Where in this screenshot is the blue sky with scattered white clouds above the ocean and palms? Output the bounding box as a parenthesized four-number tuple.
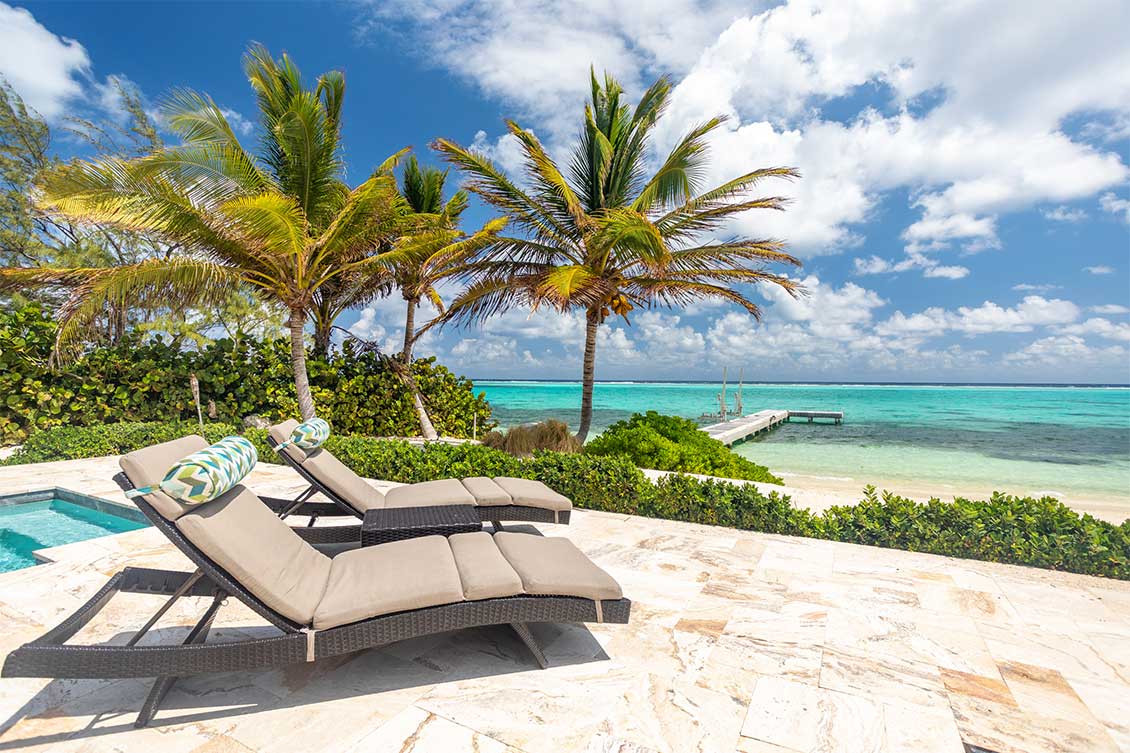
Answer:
(0, 0, 1130, 383)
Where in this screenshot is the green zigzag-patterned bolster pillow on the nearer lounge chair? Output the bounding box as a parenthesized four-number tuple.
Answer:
(128, 436, 259, 504)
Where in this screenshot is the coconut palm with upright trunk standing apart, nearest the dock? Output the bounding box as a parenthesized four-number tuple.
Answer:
(433, 73, 800, 441)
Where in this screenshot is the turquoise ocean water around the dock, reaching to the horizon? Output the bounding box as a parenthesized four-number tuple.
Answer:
(475, 381, 1130, 500)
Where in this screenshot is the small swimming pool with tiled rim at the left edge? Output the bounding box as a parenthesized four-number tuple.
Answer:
(0, 488, 149, 572)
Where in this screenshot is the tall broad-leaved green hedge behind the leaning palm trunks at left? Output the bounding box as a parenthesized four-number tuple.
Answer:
(0, 305, 494, 445)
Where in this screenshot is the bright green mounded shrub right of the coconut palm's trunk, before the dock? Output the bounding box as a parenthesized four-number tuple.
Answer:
(584, 410, 784, 484)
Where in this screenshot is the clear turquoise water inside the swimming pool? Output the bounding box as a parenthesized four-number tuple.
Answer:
(0, 499, 147, 572)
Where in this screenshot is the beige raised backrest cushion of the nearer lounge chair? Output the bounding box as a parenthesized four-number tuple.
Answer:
(121, 436, 330, 624)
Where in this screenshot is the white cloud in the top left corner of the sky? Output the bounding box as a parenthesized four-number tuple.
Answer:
(0, 2, 90, 121)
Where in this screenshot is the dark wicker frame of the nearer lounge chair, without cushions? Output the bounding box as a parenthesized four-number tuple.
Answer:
(0, 465, 632, 727)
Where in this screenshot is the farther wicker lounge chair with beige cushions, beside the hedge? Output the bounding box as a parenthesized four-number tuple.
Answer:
(267, 419, 573, 531)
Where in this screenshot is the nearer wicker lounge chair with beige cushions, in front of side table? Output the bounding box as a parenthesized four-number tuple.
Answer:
(2, 436, 632, 727)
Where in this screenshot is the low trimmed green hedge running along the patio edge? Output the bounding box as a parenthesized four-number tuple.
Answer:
(7, 423, 1130, 580)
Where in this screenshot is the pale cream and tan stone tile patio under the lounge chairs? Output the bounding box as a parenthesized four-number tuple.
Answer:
(0, 458, 1130, 753)
